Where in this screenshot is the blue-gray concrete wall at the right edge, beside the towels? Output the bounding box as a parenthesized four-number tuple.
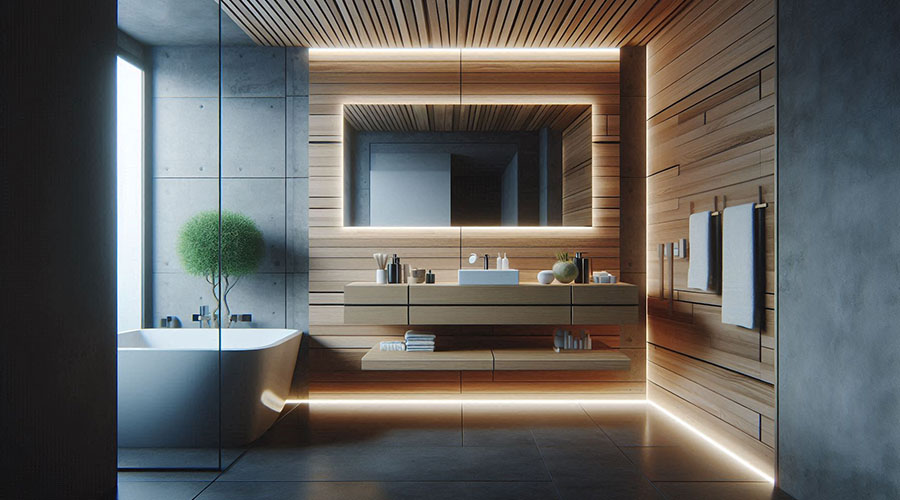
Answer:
(778, 0, 900, 499)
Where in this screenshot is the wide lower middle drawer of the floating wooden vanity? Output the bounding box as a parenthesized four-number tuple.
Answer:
(409, 305, 571, 325)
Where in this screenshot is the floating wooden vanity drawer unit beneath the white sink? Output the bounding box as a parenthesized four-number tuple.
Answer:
(344, 283, 639, 325)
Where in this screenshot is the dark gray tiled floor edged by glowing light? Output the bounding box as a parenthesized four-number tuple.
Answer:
(119, 402, 788, 500)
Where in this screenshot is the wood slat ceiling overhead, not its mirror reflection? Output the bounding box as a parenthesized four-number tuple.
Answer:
(221, 0, 690, 48)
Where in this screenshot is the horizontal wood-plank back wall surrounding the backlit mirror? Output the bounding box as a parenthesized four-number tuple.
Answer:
(309, 50, 632, 398)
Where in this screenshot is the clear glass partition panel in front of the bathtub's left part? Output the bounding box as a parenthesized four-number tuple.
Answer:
(117, 0, 227, 470)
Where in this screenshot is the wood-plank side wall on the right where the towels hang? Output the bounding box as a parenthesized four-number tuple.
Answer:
(647, 0, 775, 471)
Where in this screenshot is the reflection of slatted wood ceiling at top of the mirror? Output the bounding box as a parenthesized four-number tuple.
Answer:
(344, 104, 590, 132)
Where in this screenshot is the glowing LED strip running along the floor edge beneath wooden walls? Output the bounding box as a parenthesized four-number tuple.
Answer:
(285, 398, 775, 484)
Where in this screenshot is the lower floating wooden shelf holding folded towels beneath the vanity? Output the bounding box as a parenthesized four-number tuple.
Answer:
(362, 345, 631, 371)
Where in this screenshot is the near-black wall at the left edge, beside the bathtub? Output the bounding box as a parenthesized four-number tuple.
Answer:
(0, 0, 116, 499)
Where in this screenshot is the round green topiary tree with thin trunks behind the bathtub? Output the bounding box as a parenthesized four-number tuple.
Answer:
(178, 210, 264, 327)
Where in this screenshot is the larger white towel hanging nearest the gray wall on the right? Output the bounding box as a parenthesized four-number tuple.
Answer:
(722, 203, 758, 328)
